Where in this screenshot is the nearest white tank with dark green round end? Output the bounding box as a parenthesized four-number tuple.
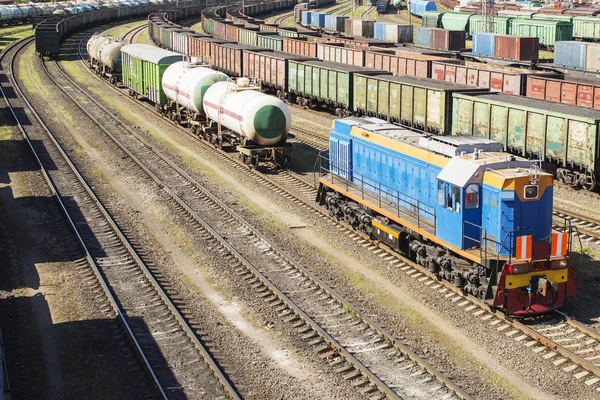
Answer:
(203, 78, 292, 146)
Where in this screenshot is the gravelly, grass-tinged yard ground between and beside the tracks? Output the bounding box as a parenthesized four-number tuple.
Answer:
(0, 9, 600, 400)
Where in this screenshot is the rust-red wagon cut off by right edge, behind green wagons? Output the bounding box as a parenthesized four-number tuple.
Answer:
(526, 76, 600, 110)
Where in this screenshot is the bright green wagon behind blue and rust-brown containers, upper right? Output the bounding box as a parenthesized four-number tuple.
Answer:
(510, 18, 573, 48)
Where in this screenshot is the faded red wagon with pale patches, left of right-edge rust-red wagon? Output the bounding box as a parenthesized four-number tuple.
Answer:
(431, 61, 561, 96)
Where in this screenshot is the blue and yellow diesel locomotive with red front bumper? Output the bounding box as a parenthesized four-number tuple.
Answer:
(317, 117, 576, 315)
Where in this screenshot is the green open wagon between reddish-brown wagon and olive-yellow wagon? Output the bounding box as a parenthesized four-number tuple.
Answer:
(288, 60, 382, 109)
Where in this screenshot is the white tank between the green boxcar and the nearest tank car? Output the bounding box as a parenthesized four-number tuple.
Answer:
(162, 61, 228, 114)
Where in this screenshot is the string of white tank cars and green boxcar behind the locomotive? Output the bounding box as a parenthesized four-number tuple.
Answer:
(87, 35, 293, 168)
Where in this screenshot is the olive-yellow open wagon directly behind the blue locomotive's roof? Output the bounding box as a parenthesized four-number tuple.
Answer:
(354, 74, 489, 135)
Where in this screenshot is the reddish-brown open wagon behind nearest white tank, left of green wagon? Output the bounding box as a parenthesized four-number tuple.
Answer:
(243, 51, 312, 94)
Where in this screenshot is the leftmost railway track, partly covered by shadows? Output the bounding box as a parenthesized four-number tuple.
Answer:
(7, 36, 239, 399)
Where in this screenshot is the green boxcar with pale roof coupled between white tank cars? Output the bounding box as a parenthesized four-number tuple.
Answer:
(121, 44, 183, 106)
